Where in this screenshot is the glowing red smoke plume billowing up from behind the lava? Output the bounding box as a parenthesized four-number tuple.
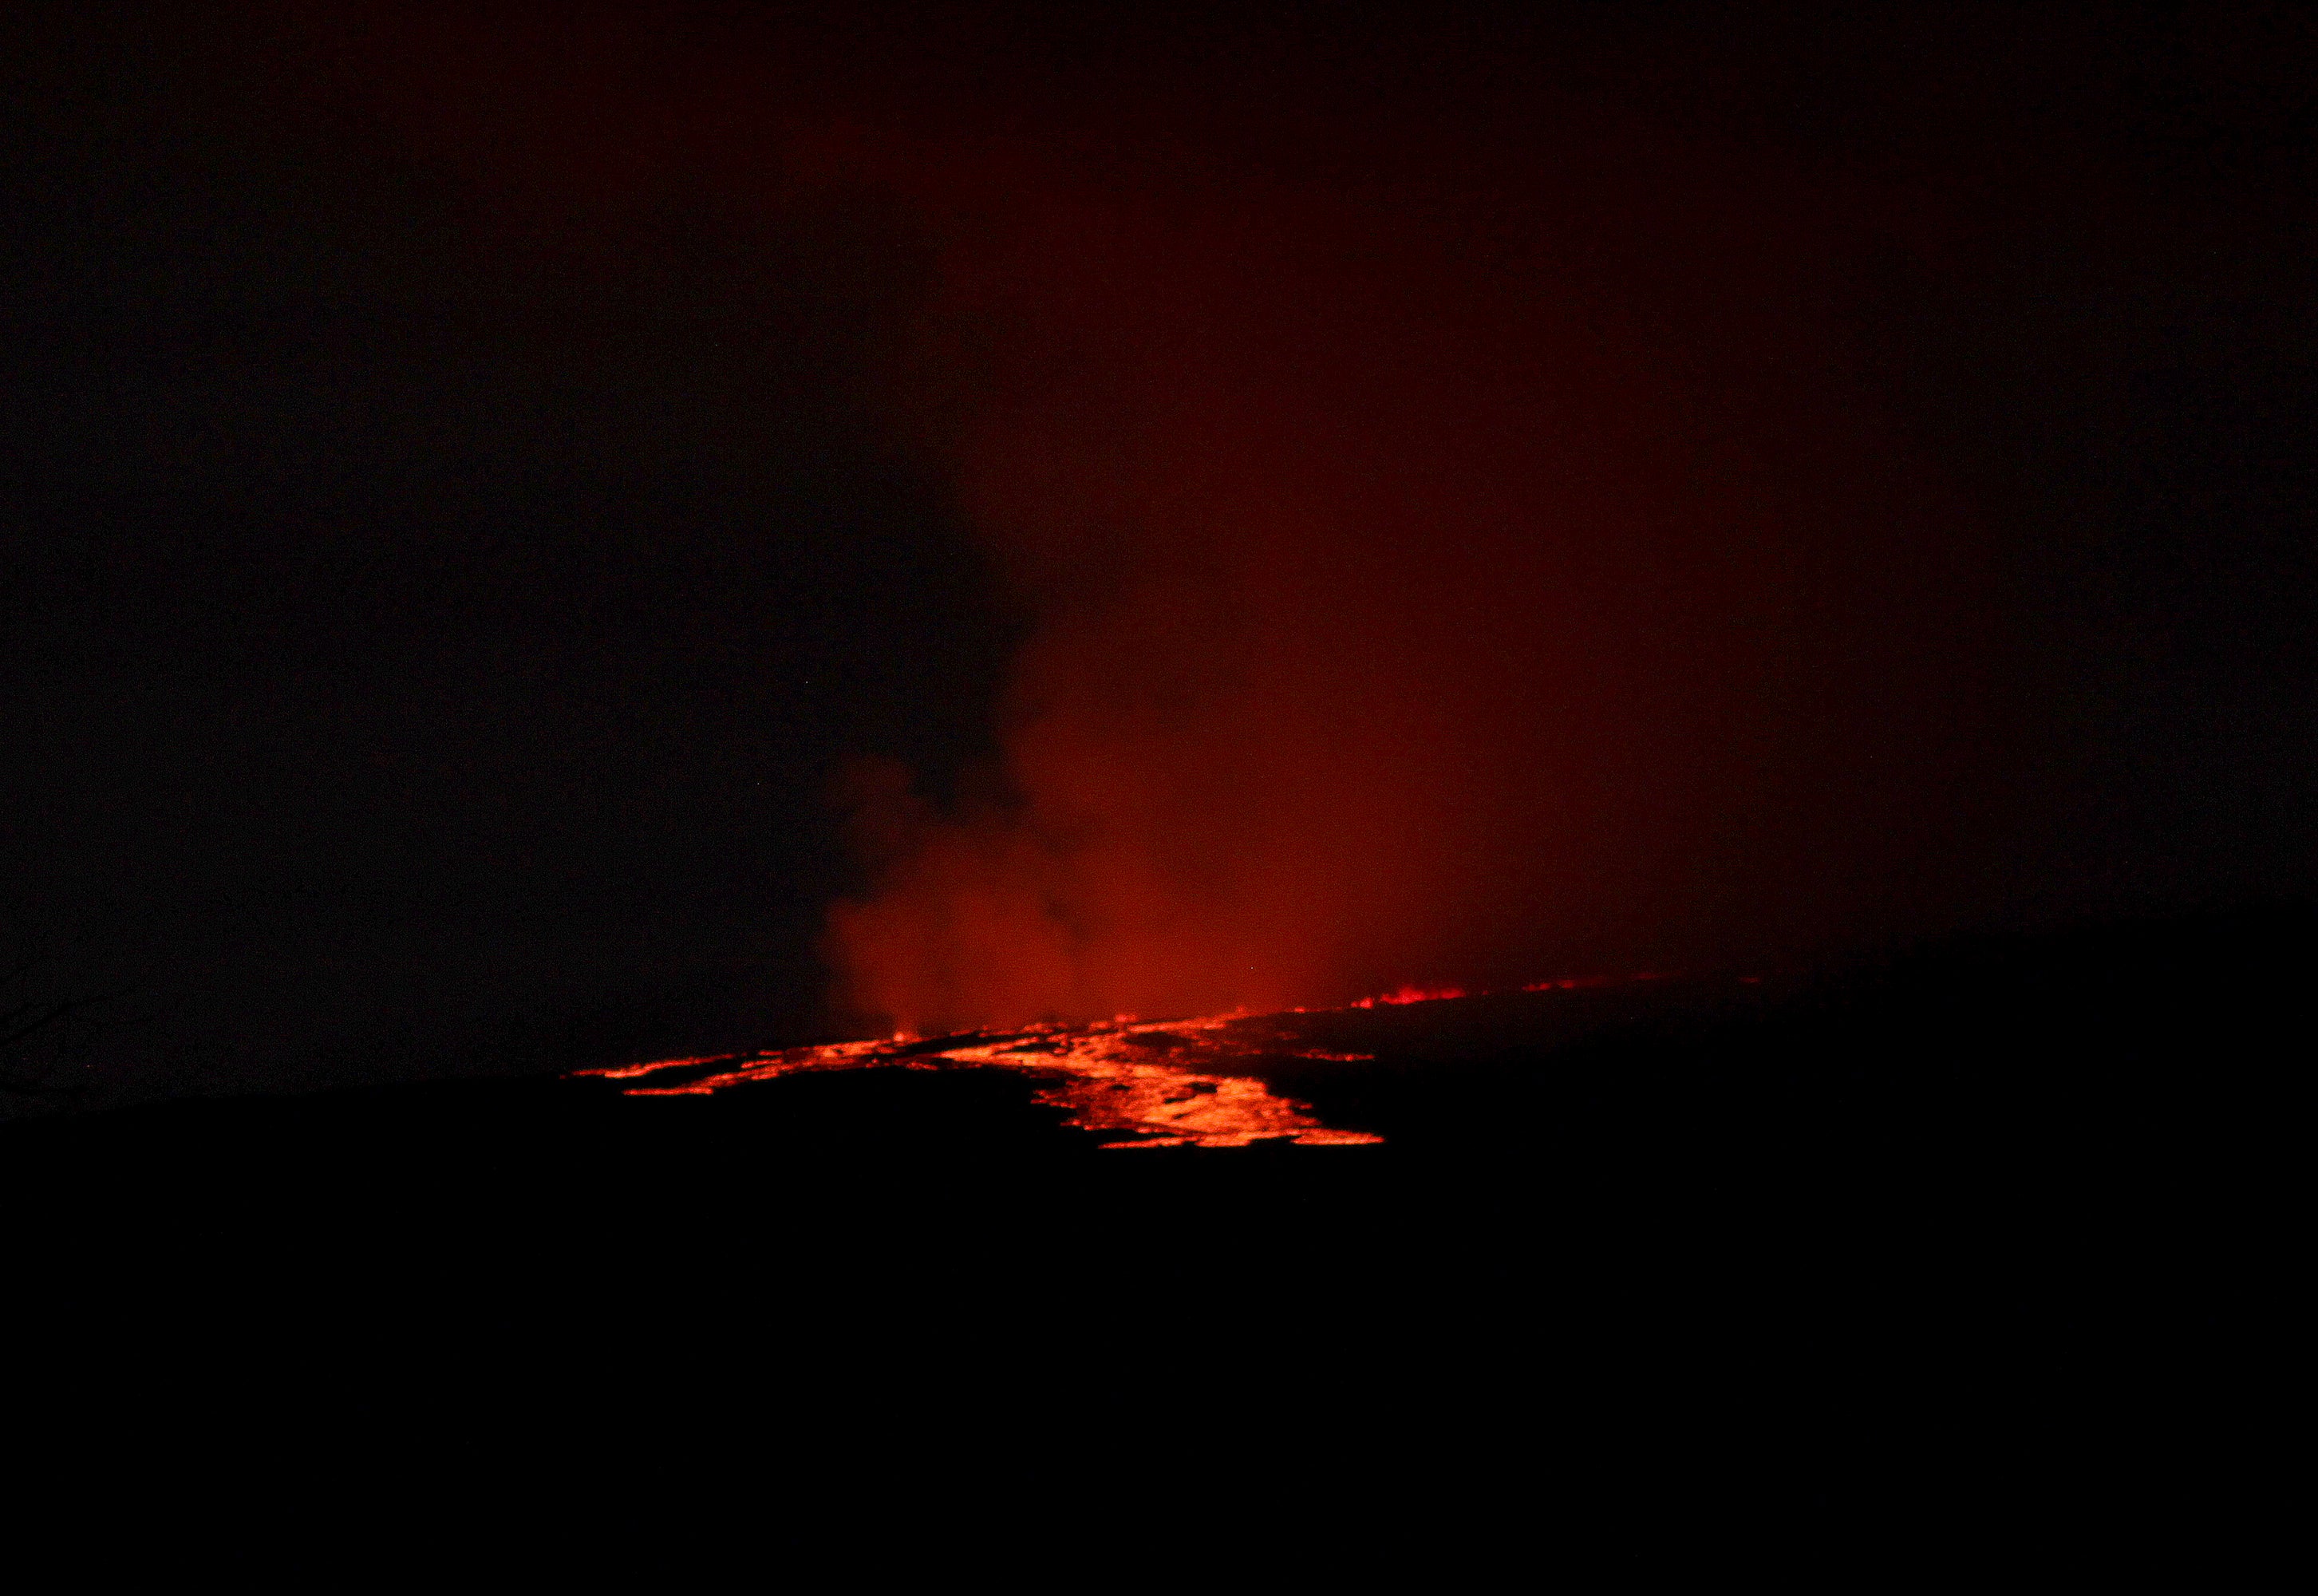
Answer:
(827, 109, 1970, 1033)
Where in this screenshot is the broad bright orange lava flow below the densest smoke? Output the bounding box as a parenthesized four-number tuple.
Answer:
(577, 1013, 1381, 1148)
